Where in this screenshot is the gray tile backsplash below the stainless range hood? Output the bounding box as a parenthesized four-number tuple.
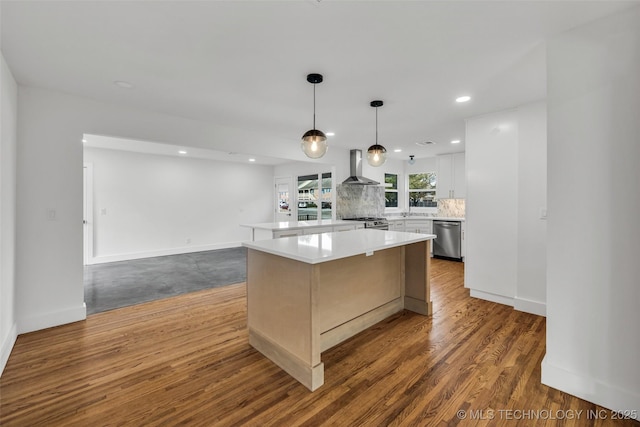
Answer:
(336, 184, 384, 219)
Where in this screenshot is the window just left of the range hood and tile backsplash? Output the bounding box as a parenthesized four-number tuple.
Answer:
(298, 172, 332, 221)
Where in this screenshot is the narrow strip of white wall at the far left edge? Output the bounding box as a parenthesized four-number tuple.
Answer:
(0, 52, 18, 374)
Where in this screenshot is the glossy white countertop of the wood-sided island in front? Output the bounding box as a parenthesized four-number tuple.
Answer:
(242, 231, 436, 264)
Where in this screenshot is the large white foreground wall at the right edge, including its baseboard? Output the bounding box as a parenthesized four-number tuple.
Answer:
(542, 8, 640, 413)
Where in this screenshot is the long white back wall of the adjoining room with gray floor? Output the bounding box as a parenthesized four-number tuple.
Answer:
(84, 148, 273, 263)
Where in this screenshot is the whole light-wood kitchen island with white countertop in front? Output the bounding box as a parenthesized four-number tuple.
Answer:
(243, 229, 435, 391)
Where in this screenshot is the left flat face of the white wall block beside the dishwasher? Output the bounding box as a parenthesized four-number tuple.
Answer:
(465, 110, 518, 305)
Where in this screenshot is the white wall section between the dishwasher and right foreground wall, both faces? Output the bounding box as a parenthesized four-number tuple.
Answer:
(465, 102, 547, 315)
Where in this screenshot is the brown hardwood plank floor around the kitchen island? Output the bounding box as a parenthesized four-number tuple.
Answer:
(0, 259, 640, 426)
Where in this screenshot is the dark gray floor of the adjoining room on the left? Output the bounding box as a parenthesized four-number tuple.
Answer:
(84, 247, 247, 315)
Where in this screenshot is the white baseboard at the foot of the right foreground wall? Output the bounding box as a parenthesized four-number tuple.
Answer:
(542, 355, 640, 419)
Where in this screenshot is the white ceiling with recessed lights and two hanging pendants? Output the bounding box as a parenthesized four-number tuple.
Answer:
(1, 0, 639, 159)
